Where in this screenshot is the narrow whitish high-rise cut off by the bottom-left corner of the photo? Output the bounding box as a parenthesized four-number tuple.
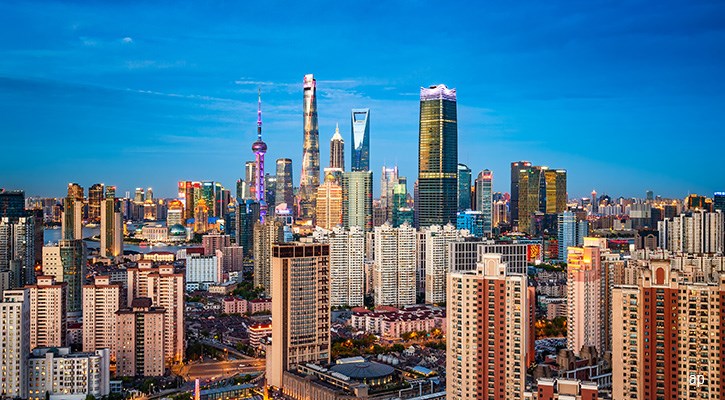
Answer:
(0, 289, 30, 399)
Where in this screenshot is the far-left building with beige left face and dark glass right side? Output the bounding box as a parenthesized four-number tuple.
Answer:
(43, 240, 88, 314)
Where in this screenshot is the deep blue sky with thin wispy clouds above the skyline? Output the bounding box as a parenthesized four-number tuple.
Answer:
(0, 1, 725, 197)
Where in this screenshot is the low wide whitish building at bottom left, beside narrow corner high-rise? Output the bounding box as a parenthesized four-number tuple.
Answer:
(28, 347, 111, 400)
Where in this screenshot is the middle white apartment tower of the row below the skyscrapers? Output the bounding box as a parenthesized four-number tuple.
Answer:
(373, 223, 416, 307)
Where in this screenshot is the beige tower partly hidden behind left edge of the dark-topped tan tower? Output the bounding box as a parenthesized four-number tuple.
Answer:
(254, 219, 284, 297)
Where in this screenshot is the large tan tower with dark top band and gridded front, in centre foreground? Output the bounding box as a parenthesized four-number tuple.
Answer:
(266, 243, 330, 387)
